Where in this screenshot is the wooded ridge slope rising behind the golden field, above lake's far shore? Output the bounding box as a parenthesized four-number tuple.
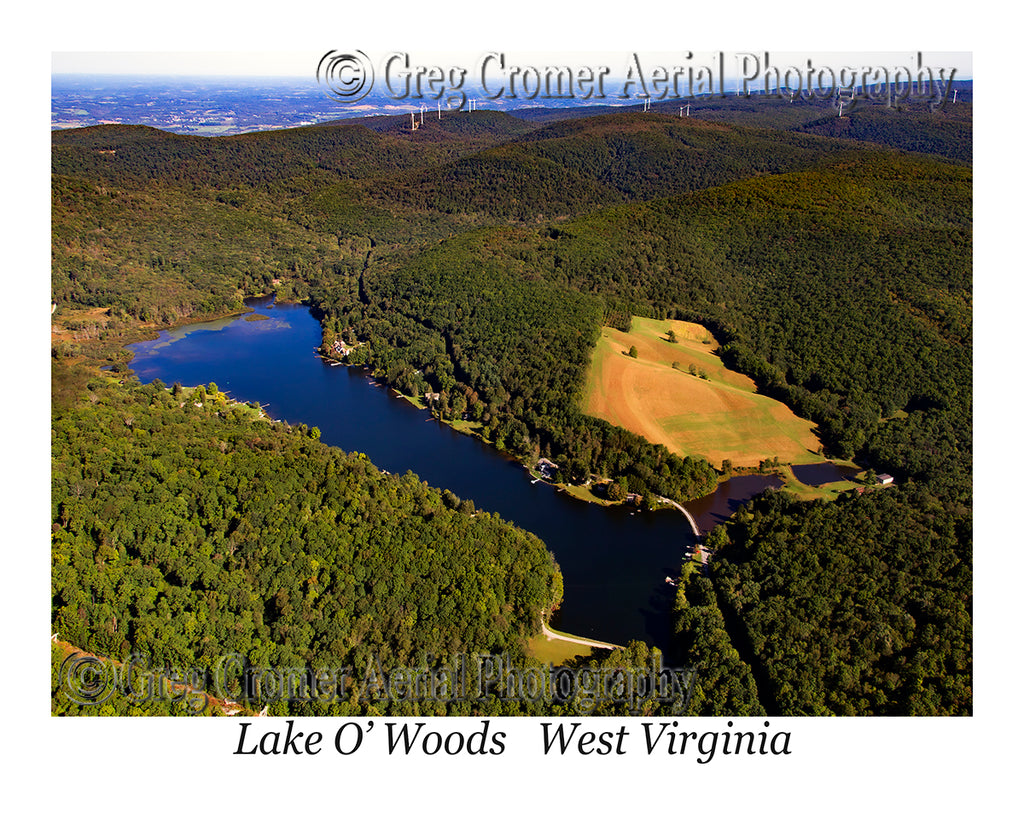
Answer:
(313, 148, 971, 507)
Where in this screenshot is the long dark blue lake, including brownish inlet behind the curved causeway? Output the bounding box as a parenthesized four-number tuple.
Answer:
(129, 299, 766, 647)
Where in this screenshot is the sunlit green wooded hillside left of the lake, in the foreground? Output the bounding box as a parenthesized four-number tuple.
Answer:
(51, 380, 561, 708)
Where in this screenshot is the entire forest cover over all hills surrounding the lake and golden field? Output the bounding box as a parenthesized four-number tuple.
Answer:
(52, 92, 973, 714)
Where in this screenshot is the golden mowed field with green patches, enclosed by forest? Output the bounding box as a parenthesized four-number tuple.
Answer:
(583, 317, 822, 467)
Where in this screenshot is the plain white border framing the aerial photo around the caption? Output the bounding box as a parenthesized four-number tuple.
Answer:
(12, 0, 1021, 816)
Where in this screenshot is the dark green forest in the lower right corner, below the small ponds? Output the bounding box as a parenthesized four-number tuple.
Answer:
(713, 489, 972, 715)
